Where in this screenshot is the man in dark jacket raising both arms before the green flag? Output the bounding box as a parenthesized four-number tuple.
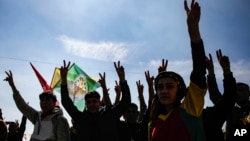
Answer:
(60, 60, 131, 141)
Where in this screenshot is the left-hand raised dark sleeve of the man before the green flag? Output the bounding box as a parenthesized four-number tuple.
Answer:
(61, 85, 81, 122)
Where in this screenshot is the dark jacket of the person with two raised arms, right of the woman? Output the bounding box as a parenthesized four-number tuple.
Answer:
(203, 73, 236, 141)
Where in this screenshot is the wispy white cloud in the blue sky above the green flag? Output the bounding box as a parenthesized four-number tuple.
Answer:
(58, 35, 131, 61)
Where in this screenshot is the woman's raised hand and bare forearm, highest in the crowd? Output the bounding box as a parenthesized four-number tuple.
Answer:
(184, 0, 201, 42)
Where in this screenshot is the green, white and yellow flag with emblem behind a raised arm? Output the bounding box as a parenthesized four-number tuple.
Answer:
(51, 63, 100, 111)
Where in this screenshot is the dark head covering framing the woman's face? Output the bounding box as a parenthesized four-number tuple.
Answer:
(154, 71, 187, 102)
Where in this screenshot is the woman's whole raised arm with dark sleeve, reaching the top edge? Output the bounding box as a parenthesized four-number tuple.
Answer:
(184, 0, 206, 88)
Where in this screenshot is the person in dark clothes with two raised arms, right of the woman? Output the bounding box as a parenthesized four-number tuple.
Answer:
(203, 50, 236, 141)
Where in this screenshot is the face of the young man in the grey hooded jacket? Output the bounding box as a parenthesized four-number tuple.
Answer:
(40, 97, 55, 113)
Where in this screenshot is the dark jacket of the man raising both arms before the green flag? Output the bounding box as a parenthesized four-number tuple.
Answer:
(61, 82, 131, 141)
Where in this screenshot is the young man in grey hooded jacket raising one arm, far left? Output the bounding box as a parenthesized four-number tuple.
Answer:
(4, 71, 70, 141)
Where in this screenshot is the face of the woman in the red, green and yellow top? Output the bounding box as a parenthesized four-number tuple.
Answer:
(157, 77, 178, 106)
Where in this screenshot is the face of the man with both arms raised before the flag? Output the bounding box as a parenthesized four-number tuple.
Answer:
(85, 98, 101, 113)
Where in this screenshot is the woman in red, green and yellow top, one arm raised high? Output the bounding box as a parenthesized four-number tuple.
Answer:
(149, 0, 207, 141)
